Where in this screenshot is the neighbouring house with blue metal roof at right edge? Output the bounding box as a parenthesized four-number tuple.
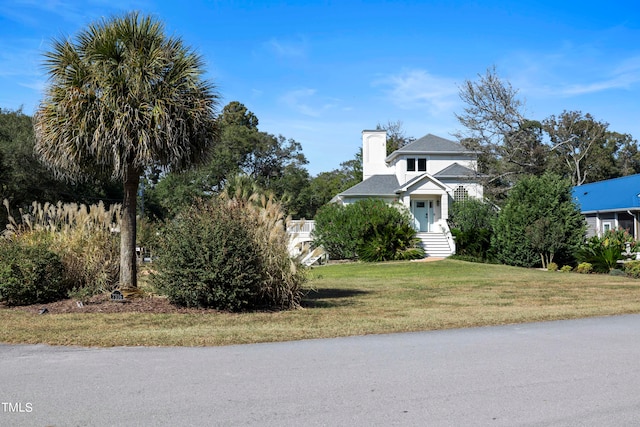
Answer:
(572, 174, 640, 239)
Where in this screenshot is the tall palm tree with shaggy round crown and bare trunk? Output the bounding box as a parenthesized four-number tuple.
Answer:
(34, 12, 219, 288)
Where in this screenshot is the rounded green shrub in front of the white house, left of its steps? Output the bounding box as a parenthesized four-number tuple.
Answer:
(313, 199, 424, 261)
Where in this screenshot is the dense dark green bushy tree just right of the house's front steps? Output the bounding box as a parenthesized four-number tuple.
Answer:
(491, 174, 586, 267)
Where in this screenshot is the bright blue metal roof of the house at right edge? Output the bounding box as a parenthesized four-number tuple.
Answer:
(573, 174, 640, 213)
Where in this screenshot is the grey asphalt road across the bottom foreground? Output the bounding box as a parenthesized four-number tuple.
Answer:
(0, 315, 640, 426)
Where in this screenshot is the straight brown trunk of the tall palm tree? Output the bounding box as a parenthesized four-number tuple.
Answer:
(120, 166, 140, 289)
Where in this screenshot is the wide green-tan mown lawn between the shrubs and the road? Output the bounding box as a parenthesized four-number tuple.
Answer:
(0, 260, 640, 346)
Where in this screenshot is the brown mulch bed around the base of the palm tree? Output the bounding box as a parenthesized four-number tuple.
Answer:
(0, 294, 217, 314)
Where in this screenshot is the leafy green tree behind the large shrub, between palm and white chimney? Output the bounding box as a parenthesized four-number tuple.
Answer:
(145, 101, 310, 218)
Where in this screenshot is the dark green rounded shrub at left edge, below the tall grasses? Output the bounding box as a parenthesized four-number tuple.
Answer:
(0, 240, 69, 305)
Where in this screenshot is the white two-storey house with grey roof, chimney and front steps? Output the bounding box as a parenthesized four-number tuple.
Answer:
(332, 130, 483, 257)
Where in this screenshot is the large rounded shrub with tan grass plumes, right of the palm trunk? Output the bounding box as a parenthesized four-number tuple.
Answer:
(151, 196, 304, 311)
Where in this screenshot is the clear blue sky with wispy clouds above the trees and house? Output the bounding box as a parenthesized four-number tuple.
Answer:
(0, 0, 640, 175)
